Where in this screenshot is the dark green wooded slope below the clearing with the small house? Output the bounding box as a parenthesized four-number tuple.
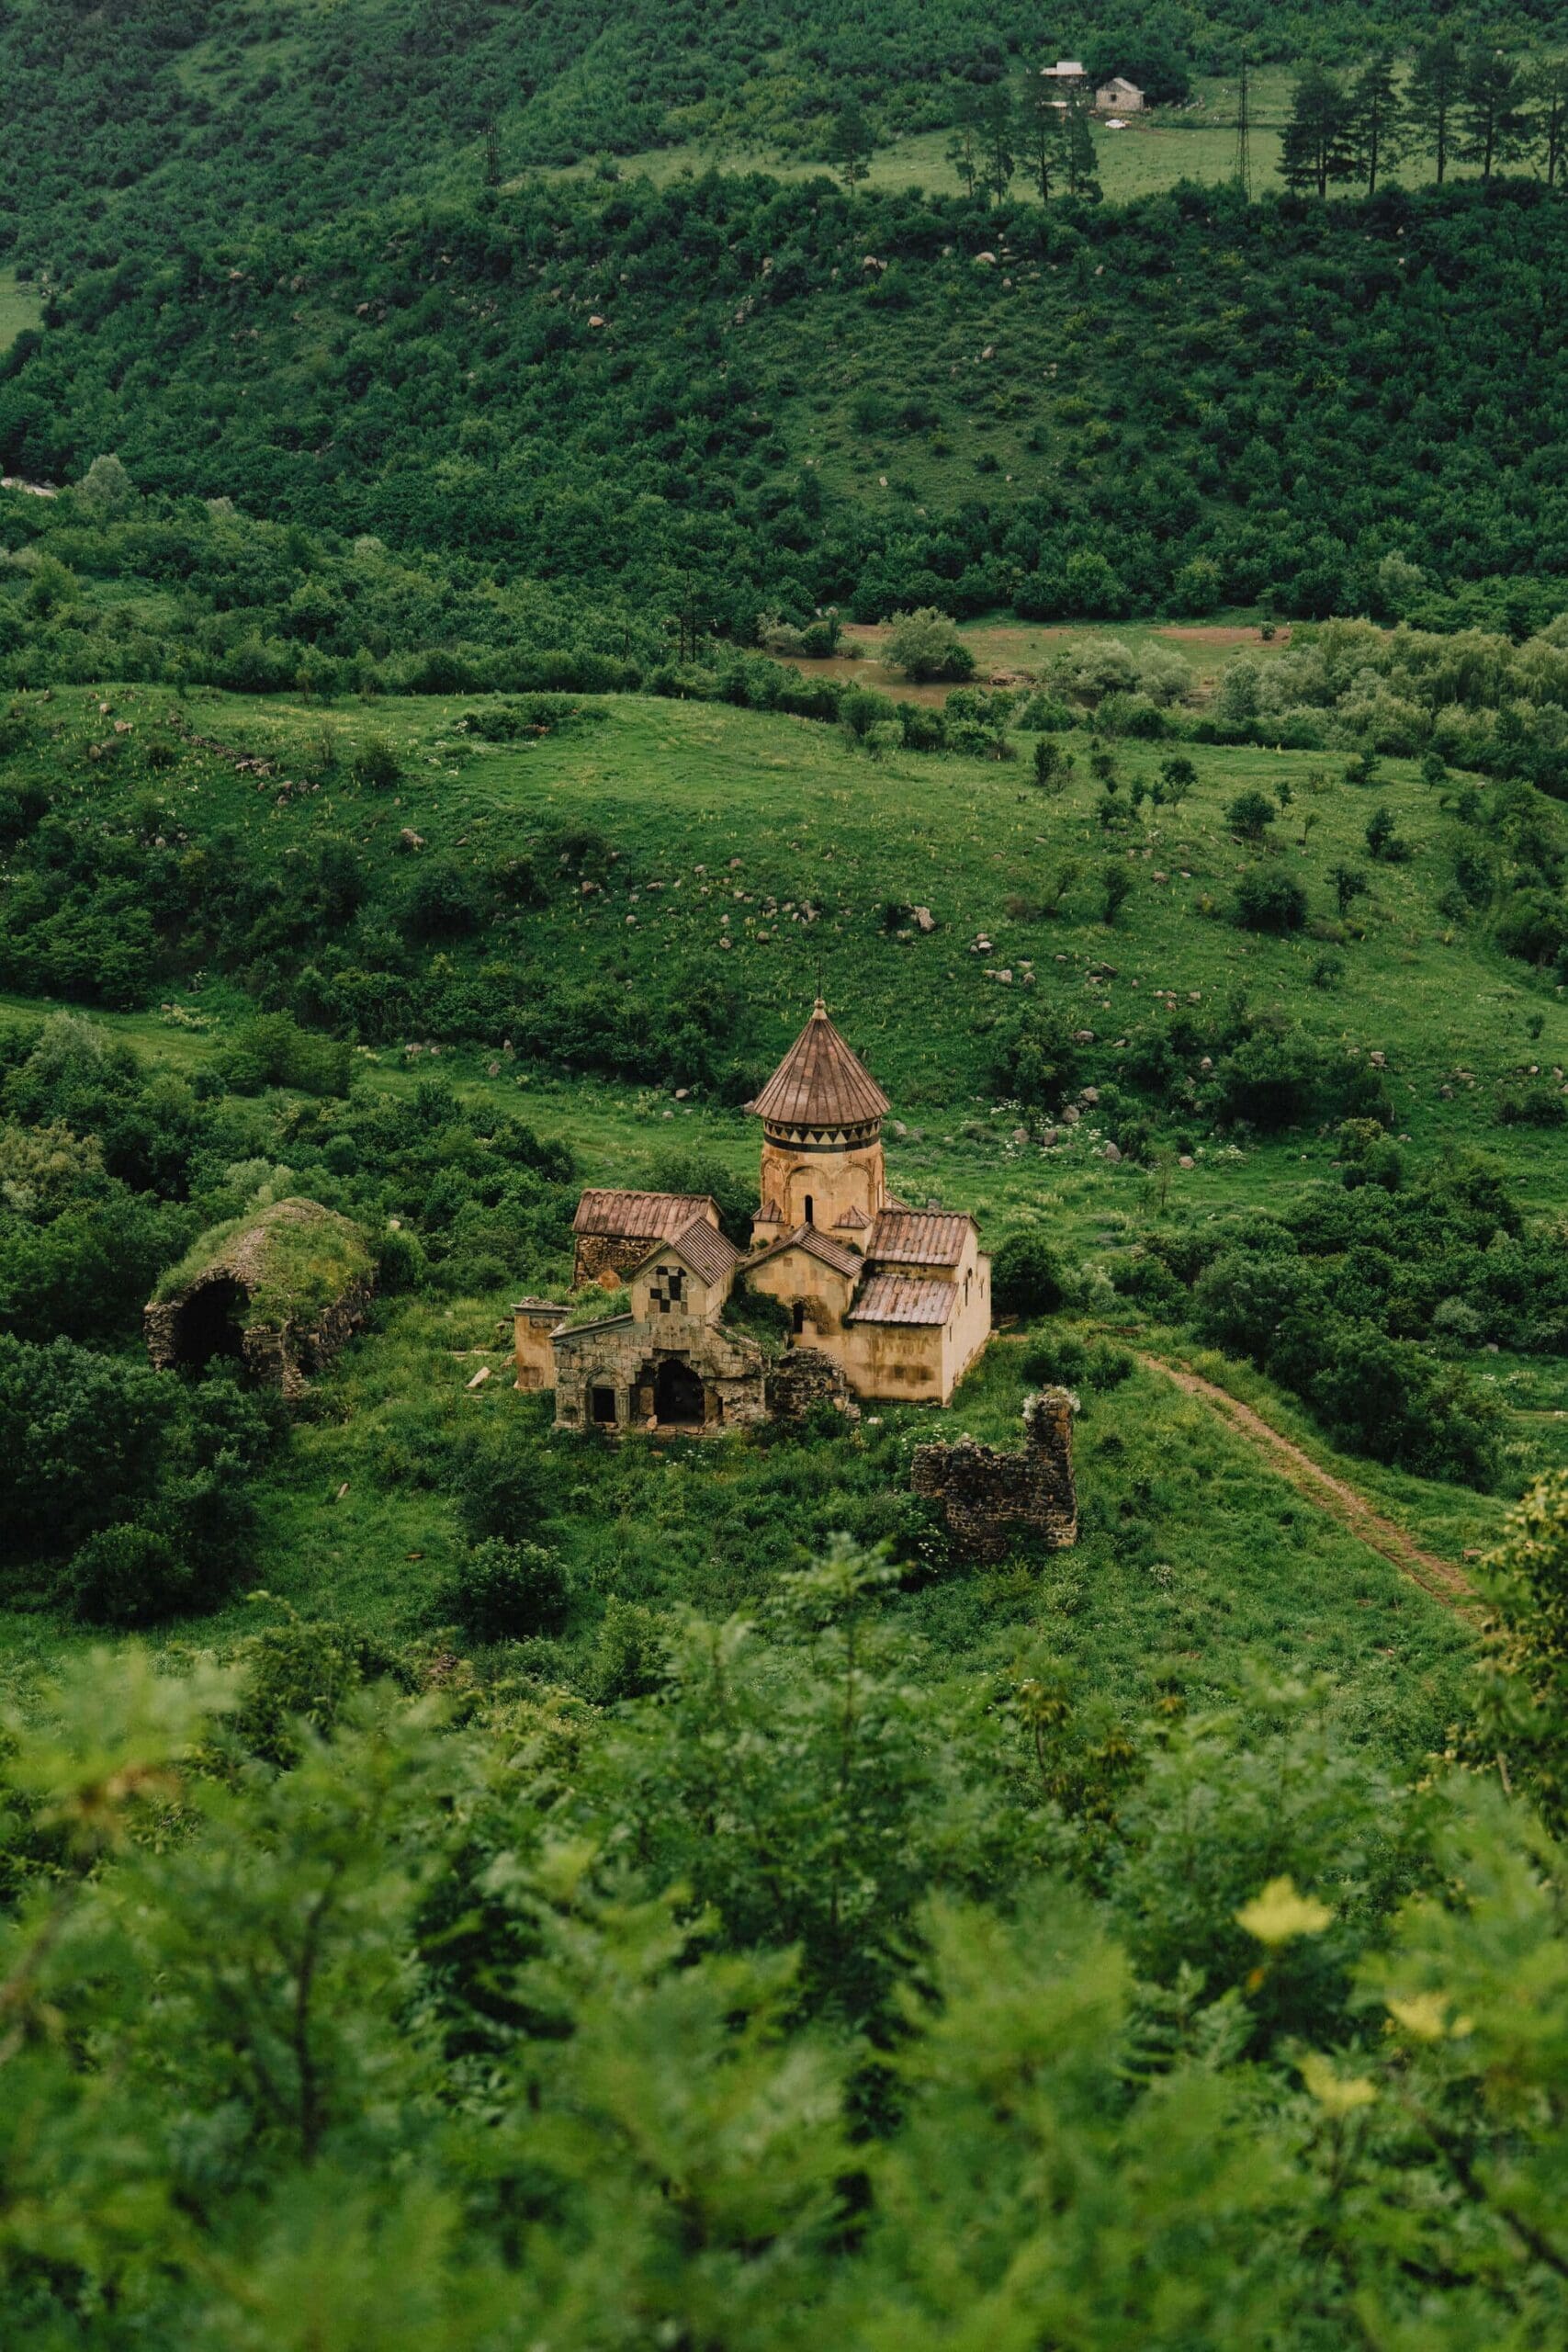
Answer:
(0, 174, 1568, 651)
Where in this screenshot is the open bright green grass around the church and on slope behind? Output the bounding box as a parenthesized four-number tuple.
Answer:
(3, 689, 1568, 1755)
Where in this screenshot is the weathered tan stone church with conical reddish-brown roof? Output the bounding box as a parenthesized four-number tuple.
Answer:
(514, 997, 989, 1430)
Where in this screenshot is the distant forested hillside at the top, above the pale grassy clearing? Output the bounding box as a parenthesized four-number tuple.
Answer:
(0, 0, 1563, 270)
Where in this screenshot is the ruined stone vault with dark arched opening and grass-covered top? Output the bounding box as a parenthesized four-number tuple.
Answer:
(143, 1200, 376, 1397)
